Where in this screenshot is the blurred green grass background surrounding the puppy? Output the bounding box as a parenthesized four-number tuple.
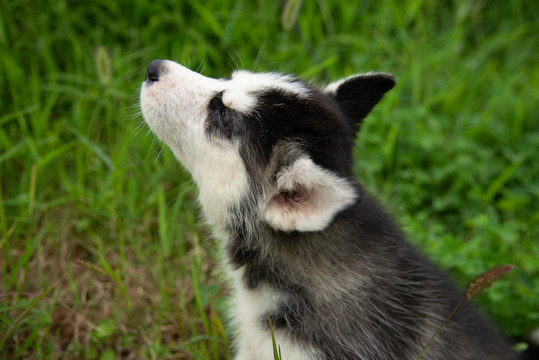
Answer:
(0, 0, 539, 360)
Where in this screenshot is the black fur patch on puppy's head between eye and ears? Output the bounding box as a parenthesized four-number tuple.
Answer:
(239, 90, 354, 177)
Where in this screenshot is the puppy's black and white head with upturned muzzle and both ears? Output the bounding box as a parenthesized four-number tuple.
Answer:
(140, 60, 395, 231)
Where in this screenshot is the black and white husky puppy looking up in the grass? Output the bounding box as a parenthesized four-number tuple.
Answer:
(140, 60, 515, 360)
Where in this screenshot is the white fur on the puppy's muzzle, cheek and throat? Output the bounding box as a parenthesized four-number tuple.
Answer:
(140, 61, 248, 225)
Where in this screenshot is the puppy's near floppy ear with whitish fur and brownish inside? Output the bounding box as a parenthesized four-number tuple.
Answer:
(262, 157, 358, 232)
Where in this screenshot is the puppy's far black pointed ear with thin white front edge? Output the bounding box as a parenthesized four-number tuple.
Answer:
(324, 73, 396, 131)
